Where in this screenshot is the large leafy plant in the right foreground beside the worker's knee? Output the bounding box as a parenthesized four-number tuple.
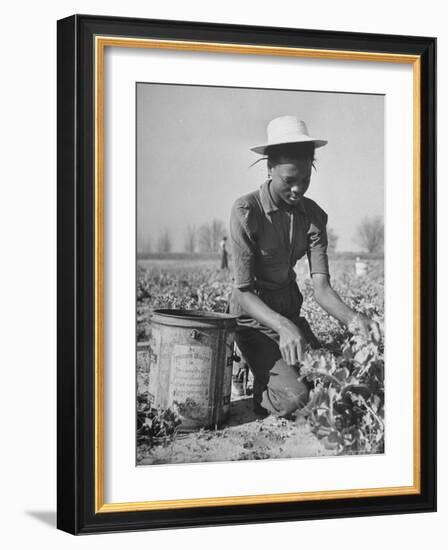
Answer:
(300, 335, 384, 454)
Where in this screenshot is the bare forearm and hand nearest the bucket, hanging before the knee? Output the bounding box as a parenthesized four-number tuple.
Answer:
(234, 289, 305, 365)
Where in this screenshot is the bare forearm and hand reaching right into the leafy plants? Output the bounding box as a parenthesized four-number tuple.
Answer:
(312, 273, 381, 341)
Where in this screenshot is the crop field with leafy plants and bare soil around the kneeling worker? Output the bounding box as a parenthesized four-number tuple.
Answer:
(137, 259, 385, 464)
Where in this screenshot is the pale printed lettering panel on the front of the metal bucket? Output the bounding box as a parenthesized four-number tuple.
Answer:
(168, 344, 212, 418)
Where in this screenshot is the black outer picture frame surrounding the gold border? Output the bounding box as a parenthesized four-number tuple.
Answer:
(57, 15, 436, 534)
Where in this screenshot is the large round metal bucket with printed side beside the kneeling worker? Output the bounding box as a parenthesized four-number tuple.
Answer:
(148, 309, 236, 430)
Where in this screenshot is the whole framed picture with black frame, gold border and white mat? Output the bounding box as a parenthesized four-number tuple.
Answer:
(58, 15, 436, 534)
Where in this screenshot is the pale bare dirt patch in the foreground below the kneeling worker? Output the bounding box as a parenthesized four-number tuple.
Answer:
(137, 396, 335, 465)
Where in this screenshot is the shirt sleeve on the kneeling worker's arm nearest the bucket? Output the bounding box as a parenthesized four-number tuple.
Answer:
(230, 199, 256, 289)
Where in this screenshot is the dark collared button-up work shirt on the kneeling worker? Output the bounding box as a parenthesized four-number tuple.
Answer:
(230, 180, 329, 290)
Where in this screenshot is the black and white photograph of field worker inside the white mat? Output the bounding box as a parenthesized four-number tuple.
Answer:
(136, 82, 387, 466)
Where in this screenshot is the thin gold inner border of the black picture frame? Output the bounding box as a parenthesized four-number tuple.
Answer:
(94, 36, 421, 513)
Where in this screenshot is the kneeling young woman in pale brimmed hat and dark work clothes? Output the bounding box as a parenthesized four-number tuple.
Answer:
(229, 116, 380, 416)
